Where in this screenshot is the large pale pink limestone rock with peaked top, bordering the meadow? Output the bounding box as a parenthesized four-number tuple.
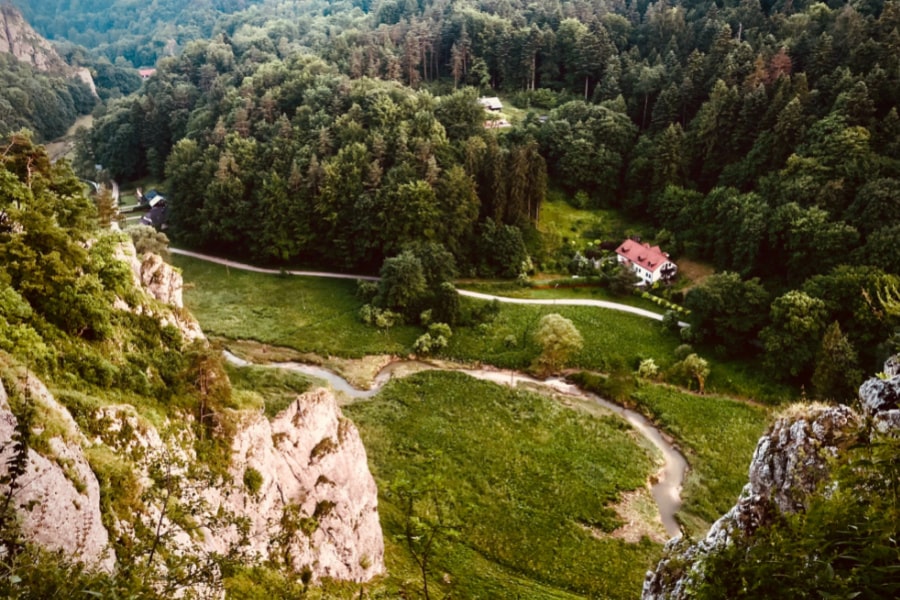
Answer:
(210, 389, 384, 581)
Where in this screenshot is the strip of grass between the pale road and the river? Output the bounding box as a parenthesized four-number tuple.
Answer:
(178, 256, 791, 403)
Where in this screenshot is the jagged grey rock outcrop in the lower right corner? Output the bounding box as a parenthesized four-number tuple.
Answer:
(642, 357, 900, 600)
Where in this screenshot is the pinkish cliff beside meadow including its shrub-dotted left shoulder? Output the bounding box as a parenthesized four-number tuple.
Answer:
(94, 389, 384, 586)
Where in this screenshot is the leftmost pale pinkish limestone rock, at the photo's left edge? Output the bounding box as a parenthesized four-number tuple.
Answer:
(0, 373, 115, 571)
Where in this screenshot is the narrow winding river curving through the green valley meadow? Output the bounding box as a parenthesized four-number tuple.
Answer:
(225, 351, 688, 537)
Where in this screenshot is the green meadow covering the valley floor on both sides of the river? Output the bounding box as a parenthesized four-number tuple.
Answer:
(181, 251, 778, 598)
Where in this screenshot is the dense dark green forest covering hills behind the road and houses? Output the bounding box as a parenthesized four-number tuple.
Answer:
(17, 0, 900, 394)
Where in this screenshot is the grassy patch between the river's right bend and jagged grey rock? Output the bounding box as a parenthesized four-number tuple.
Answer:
(632, 385, 769, 533)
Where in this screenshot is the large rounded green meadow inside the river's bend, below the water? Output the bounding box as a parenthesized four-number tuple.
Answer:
(344, 372, 660, 598)
